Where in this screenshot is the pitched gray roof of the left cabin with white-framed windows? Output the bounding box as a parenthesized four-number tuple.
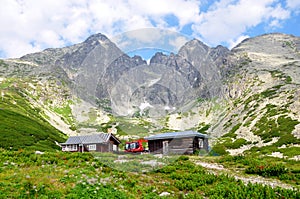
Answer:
(62, 133, 115, 145)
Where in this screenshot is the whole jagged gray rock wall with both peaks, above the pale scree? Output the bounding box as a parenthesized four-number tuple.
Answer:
(1, 33, 233, 115)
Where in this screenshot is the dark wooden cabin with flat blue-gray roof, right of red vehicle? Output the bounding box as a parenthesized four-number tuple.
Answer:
(145, 131, 208, 154)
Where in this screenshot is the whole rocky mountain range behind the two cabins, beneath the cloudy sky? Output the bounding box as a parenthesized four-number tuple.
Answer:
(0, 33, 300, 158)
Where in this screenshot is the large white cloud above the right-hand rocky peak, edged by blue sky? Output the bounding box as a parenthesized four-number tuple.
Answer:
(192, 0, 290, 45)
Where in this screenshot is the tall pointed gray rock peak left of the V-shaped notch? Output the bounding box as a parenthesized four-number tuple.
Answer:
(55, 34, 123, 102)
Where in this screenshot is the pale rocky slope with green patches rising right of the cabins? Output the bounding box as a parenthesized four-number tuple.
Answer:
(207, 34, 300, 158)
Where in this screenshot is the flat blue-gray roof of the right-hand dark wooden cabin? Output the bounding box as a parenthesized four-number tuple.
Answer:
(145, 131, 208, 140)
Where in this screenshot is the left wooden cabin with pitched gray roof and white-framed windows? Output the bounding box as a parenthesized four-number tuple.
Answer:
(60, 133, 121, 152)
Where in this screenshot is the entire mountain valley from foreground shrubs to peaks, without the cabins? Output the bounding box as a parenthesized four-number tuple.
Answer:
(0, 33, 300, 198)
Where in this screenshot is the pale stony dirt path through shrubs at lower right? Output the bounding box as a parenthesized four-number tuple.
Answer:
(194, 160, 295, 189)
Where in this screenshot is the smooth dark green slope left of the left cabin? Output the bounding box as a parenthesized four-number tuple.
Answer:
(0, 79, 65, 151)
